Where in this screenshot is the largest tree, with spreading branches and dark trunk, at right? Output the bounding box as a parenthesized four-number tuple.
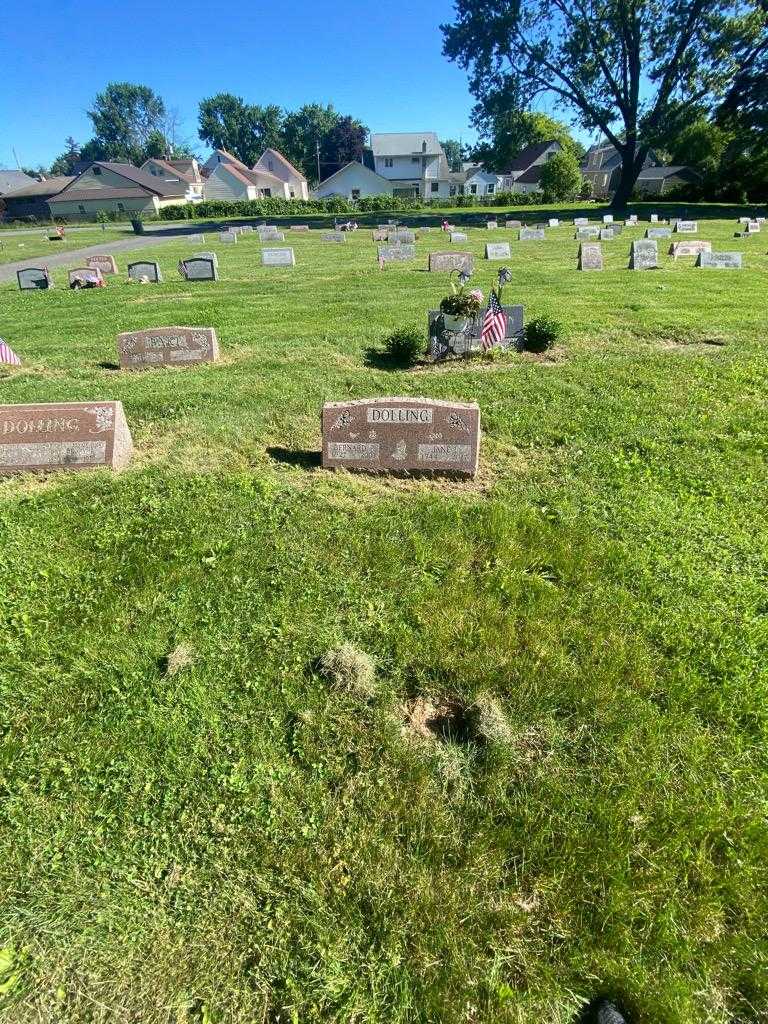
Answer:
(441, 0, 768, 208)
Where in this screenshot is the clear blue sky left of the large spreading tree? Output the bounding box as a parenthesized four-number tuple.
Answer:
(0, 0, 524, 167)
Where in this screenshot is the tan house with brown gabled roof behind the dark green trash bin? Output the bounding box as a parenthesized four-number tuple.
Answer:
(47, 160, 186, 220)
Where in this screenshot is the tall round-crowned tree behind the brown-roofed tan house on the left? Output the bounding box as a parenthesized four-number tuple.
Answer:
(88, 82, 166, 164)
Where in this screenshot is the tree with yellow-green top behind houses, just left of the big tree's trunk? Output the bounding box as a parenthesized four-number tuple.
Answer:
(472, 105, 584, 173)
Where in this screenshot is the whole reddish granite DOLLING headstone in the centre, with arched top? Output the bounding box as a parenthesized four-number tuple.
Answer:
(323, 396, 480, 476)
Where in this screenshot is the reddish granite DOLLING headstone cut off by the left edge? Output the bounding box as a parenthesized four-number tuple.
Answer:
(0, 401, 133, 473)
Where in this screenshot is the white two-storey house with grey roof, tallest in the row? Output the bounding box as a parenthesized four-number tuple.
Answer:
(371, 131, 451, 199)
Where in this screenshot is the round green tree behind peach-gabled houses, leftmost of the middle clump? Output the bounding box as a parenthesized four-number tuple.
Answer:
(198, 92, 284, 167)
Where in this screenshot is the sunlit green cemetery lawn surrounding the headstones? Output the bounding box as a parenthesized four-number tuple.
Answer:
(0, 212, 768, 1024)
